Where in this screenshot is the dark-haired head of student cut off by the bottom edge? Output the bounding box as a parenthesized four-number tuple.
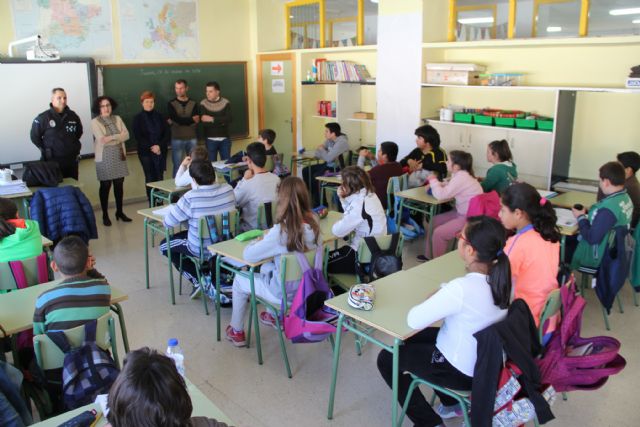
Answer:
(107, 347, 227, 427)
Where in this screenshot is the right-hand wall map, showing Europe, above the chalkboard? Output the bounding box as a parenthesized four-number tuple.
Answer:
(119, 0, 199, 60)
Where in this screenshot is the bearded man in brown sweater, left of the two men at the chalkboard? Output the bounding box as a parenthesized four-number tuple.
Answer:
(168, 79, 200, 178)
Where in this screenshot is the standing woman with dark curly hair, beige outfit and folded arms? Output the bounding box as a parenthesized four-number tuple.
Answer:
(91, 96, 131, 227)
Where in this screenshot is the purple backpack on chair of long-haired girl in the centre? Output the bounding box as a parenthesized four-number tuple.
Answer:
(281, 246, 336, 344)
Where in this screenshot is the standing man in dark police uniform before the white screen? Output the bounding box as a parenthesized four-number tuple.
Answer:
(31, 87, 82, 180)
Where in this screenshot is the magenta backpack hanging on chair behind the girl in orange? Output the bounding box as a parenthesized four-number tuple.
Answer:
(536, 279, 627, 392)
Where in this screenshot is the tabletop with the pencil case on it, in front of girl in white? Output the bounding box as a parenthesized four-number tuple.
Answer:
(325, 251, 465, 341)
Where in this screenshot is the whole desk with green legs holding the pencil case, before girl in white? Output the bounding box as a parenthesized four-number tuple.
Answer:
(325, 253, 465, 426)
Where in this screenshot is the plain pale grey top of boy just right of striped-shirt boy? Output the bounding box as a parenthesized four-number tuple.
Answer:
(233, 172, 280, 231)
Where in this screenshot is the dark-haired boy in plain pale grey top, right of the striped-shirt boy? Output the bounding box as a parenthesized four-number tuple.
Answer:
(233, 142, 280, 231)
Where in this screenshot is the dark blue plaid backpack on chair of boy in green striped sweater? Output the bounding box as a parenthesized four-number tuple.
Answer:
(47, 320, 120, 410)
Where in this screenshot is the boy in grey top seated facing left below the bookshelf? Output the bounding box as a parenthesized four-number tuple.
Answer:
(302, 122, 349, 205)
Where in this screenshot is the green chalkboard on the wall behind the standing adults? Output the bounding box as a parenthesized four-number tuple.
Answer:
(101, 62, 249, 150)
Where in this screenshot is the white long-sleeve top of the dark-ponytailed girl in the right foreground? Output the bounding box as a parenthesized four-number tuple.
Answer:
(407, 273, 507, 377)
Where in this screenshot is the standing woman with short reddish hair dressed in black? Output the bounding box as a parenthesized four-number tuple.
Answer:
(133, 90, 171, 204)
